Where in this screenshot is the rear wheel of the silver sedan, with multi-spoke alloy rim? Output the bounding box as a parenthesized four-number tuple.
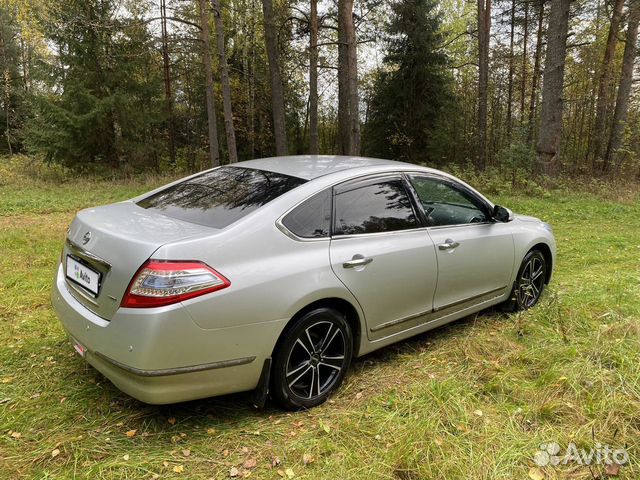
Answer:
(271, 308, 353, 410)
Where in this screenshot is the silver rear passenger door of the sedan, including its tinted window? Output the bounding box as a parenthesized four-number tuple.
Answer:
(330, 174, 437, 339)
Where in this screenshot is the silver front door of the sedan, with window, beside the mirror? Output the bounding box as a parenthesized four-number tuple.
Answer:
(409, 174, 514, 311)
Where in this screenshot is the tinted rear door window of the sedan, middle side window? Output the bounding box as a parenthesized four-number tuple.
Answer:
(334, 178, 418, 235)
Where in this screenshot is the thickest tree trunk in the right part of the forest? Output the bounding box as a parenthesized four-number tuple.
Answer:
(535, 0, 570, 176)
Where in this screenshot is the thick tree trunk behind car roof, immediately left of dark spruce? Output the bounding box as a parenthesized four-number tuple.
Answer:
(338, 0, 360, 155)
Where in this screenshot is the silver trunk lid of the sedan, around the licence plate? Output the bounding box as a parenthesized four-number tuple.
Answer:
(62, 201, 217, 320)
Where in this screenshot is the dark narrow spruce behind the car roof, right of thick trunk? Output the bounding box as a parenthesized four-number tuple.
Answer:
(364, 0, 450, 162)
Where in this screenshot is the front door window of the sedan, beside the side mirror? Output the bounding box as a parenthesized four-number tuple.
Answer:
(410, 175, 488, 227)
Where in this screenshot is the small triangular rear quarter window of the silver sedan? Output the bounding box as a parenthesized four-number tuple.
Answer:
(282, 189, 331, 238)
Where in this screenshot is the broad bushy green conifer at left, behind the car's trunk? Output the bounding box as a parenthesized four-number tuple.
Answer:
(26, 0, 163, 169)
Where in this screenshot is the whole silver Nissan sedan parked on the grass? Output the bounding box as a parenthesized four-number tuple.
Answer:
(52, 156, 556, 409)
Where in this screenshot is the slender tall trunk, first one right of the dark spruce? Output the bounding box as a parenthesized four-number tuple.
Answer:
(476, 0, 491, 171)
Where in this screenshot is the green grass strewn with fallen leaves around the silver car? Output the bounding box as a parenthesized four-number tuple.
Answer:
(0, 157, 640, 480)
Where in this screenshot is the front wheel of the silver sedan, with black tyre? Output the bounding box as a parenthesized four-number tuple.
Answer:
(506, 250, 547, 312)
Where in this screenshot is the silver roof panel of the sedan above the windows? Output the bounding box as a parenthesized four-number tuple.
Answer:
(233, 155, 416, 180)
